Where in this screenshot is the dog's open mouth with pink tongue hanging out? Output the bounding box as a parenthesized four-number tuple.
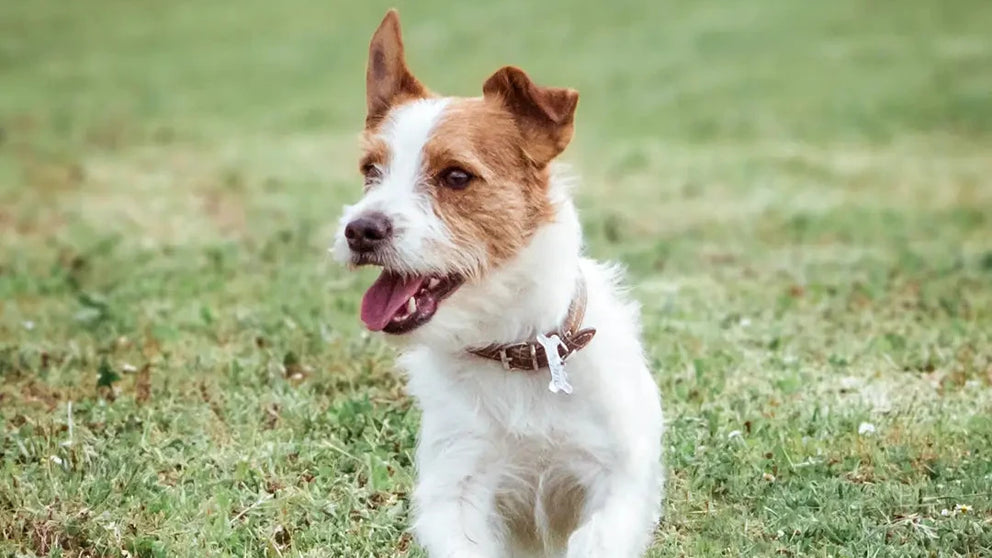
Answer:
(362, 270, 463, 334)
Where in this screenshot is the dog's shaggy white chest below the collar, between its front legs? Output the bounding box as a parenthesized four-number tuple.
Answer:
(402, 351, 628, 556)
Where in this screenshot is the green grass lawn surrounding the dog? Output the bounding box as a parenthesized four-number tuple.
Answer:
(0, 0, 992, 557)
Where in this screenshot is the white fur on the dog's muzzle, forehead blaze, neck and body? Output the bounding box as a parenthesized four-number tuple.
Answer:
(337, 101, 663, 558)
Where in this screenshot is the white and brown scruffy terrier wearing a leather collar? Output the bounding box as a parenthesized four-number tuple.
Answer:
(331, 10, 663, 558)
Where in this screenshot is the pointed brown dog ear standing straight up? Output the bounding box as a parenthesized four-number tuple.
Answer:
(365, 9, 428, 128)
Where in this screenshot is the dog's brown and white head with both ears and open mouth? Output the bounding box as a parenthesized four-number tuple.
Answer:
(334, 11, 578, 334)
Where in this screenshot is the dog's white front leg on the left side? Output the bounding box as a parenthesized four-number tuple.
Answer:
(413, 446, 500, 558)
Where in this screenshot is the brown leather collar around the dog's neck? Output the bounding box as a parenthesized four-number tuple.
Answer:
(468, 272, 596, 372)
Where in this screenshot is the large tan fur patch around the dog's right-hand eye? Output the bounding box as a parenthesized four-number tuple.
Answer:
(424, 98, 554, 272)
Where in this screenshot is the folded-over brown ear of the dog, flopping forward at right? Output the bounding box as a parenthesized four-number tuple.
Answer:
(482, 66, 579, 166)
